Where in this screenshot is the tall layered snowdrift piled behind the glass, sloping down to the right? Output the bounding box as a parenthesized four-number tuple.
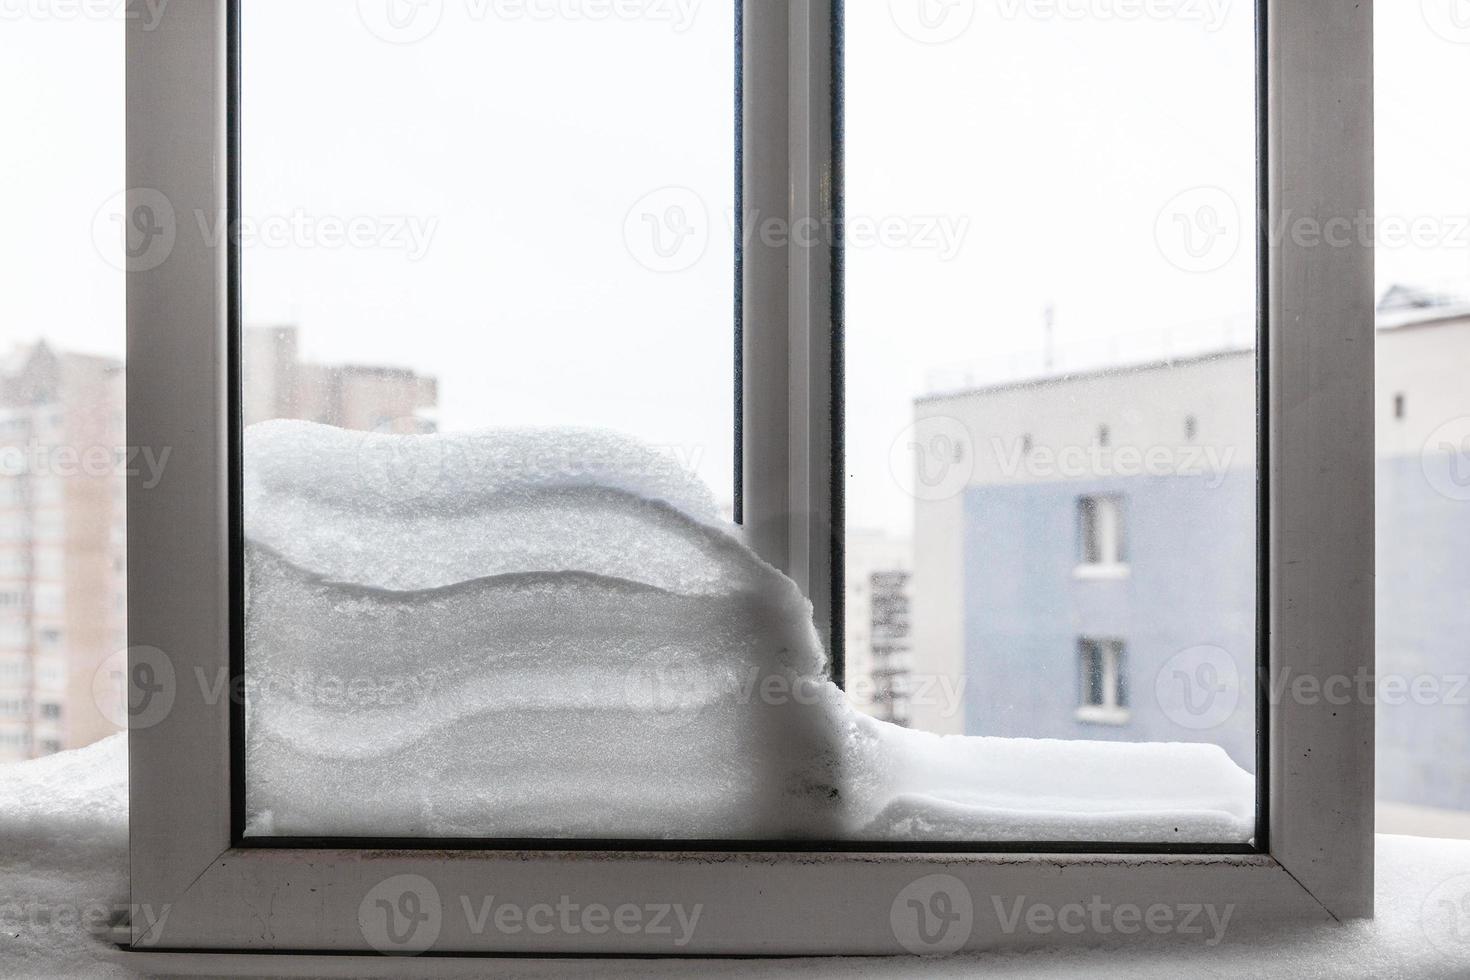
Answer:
(245, 422, 1254, 842)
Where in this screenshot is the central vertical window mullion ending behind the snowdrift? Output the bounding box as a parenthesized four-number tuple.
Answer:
(741, 0, 841, 667)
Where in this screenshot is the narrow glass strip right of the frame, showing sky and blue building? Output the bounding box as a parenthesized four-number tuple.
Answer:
(1370, 0, 1470, 840)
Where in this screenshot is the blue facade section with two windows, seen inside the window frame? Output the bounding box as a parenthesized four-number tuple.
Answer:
(963, 467, 1257, 771)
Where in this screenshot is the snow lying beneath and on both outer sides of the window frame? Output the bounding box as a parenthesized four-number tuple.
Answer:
(0, 735, 1470, 980)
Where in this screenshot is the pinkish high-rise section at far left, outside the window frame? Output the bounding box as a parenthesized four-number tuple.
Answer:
(0, 344, 126, 760)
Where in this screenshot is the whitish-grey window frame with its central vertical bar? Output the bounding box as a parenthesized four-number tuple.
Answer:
(126, 0, 1374, 968)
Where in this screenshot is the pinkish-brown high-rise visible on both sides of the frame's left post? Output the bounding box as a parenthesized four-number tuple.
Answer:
(0, 326, 438, 761)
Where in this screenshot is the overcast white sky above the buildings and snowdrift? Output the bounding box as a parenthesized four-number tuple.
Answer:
(0, 0, 1470, 529)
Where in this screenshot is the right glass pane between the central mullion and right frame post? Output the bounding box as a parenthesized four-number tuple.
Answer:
(845, 1, 1257, 842)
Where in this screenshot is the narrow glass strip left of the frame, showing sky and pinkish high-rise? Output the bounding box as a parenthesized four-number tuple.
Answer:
(0, 9, 124, 764)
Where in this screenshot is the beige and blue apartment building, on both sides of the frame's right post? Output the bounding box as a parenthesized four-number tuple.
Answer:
(913, 289, 1470, 810)
